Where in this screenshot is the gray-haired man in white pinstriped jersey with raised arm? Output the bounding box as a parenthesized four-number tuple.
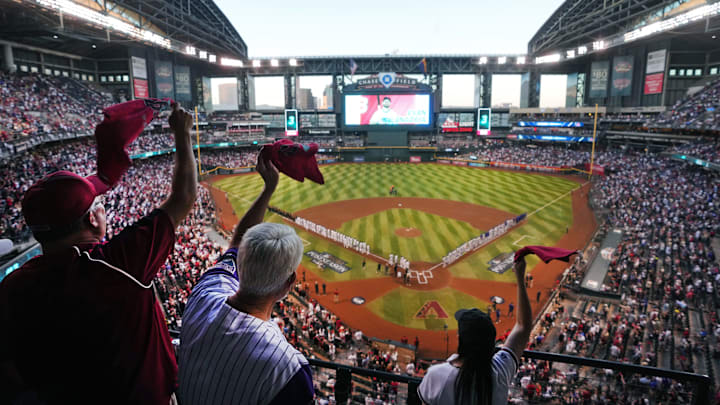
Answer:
(178, 151, 314, 405)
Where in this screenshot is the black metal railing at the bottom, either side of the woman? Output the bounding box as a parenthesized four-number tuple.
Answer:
(308, 350, 712, 405)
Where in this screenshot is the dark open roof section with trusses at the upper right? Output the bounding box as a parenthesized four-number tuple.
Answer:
(528, 0, 696, 55)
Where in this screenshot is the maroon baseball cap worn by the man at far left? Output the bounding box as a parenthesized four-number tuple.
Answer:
(22, 171, 109, 232)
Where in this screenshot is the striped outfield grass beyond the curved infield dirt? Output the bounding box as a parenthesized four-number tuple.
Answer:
(215, 164, 577, 214)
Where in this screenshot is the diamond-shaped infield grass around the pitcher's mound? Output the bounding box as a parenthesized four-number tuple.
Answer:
(339, 208, 483, 263)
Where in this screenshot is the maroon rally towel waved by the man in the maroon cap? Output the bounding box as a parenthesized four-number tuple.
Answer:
(87, 100, 154, 194)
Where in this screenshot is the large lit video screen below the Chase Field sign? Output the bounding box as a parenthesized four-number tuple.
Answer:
(343, 93, 432, 127)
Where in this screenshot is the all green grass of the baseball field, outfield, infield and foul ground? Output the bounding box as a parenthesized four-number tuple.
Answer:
(214, 164, 579, 330)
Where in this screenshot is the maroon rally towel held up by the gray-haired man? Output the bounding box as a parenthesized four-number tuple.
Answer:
(263, 139, 325, 184)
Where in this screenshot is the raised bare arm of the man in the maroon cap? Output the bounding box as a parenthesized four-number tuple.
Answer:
(160, 104, 197, 227)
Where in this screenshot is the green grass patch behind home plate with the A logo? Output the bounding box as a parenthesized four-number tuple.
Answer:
(368, 287, 489, 330)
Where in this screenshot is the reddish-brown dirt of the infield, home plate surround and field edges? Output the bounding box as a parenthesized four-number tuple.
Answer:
(203, 172, 597, 358)
